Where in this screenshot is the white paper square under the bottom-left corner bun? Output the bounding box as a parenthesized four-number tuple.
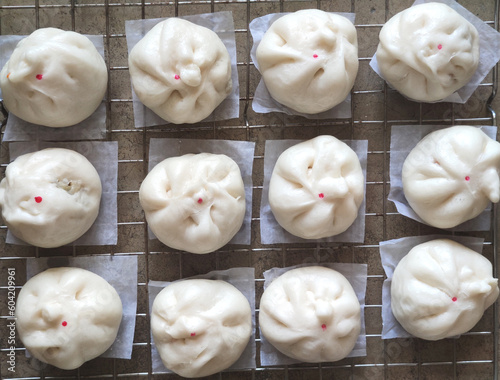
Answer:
(22, 256, 137, 367)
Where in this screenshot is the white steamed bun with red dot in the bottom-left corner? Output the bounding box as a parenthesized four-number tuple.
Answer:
(16, 267, 122, 369)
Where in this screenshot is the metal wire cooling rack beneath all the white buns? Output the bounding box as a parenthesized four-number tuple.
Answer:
(0, 0, 499, 380)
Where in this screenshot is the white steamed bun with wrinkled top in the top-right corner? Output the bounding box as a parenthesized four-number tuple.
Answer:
(376, 3, 479, 102)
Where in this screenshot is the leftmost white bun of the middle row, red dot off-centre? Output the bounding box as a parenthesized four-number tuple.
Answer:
(0, 148, 102, 248)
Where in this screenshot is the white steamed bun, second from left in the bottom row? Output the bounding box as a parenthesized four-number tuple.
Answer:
(151, 279, 252, 377)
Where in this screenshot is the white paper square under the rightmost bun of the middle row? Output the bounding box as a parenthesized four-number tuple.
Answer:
(387, 125, 497, 231)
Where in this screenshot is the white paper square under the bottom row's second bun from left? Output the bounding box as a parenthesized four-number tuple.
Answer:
(148, 268, 256, 373)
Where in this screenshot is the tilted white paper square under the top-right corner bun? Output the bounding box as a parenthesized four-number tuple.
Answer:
(370, 0, 500, 104)
